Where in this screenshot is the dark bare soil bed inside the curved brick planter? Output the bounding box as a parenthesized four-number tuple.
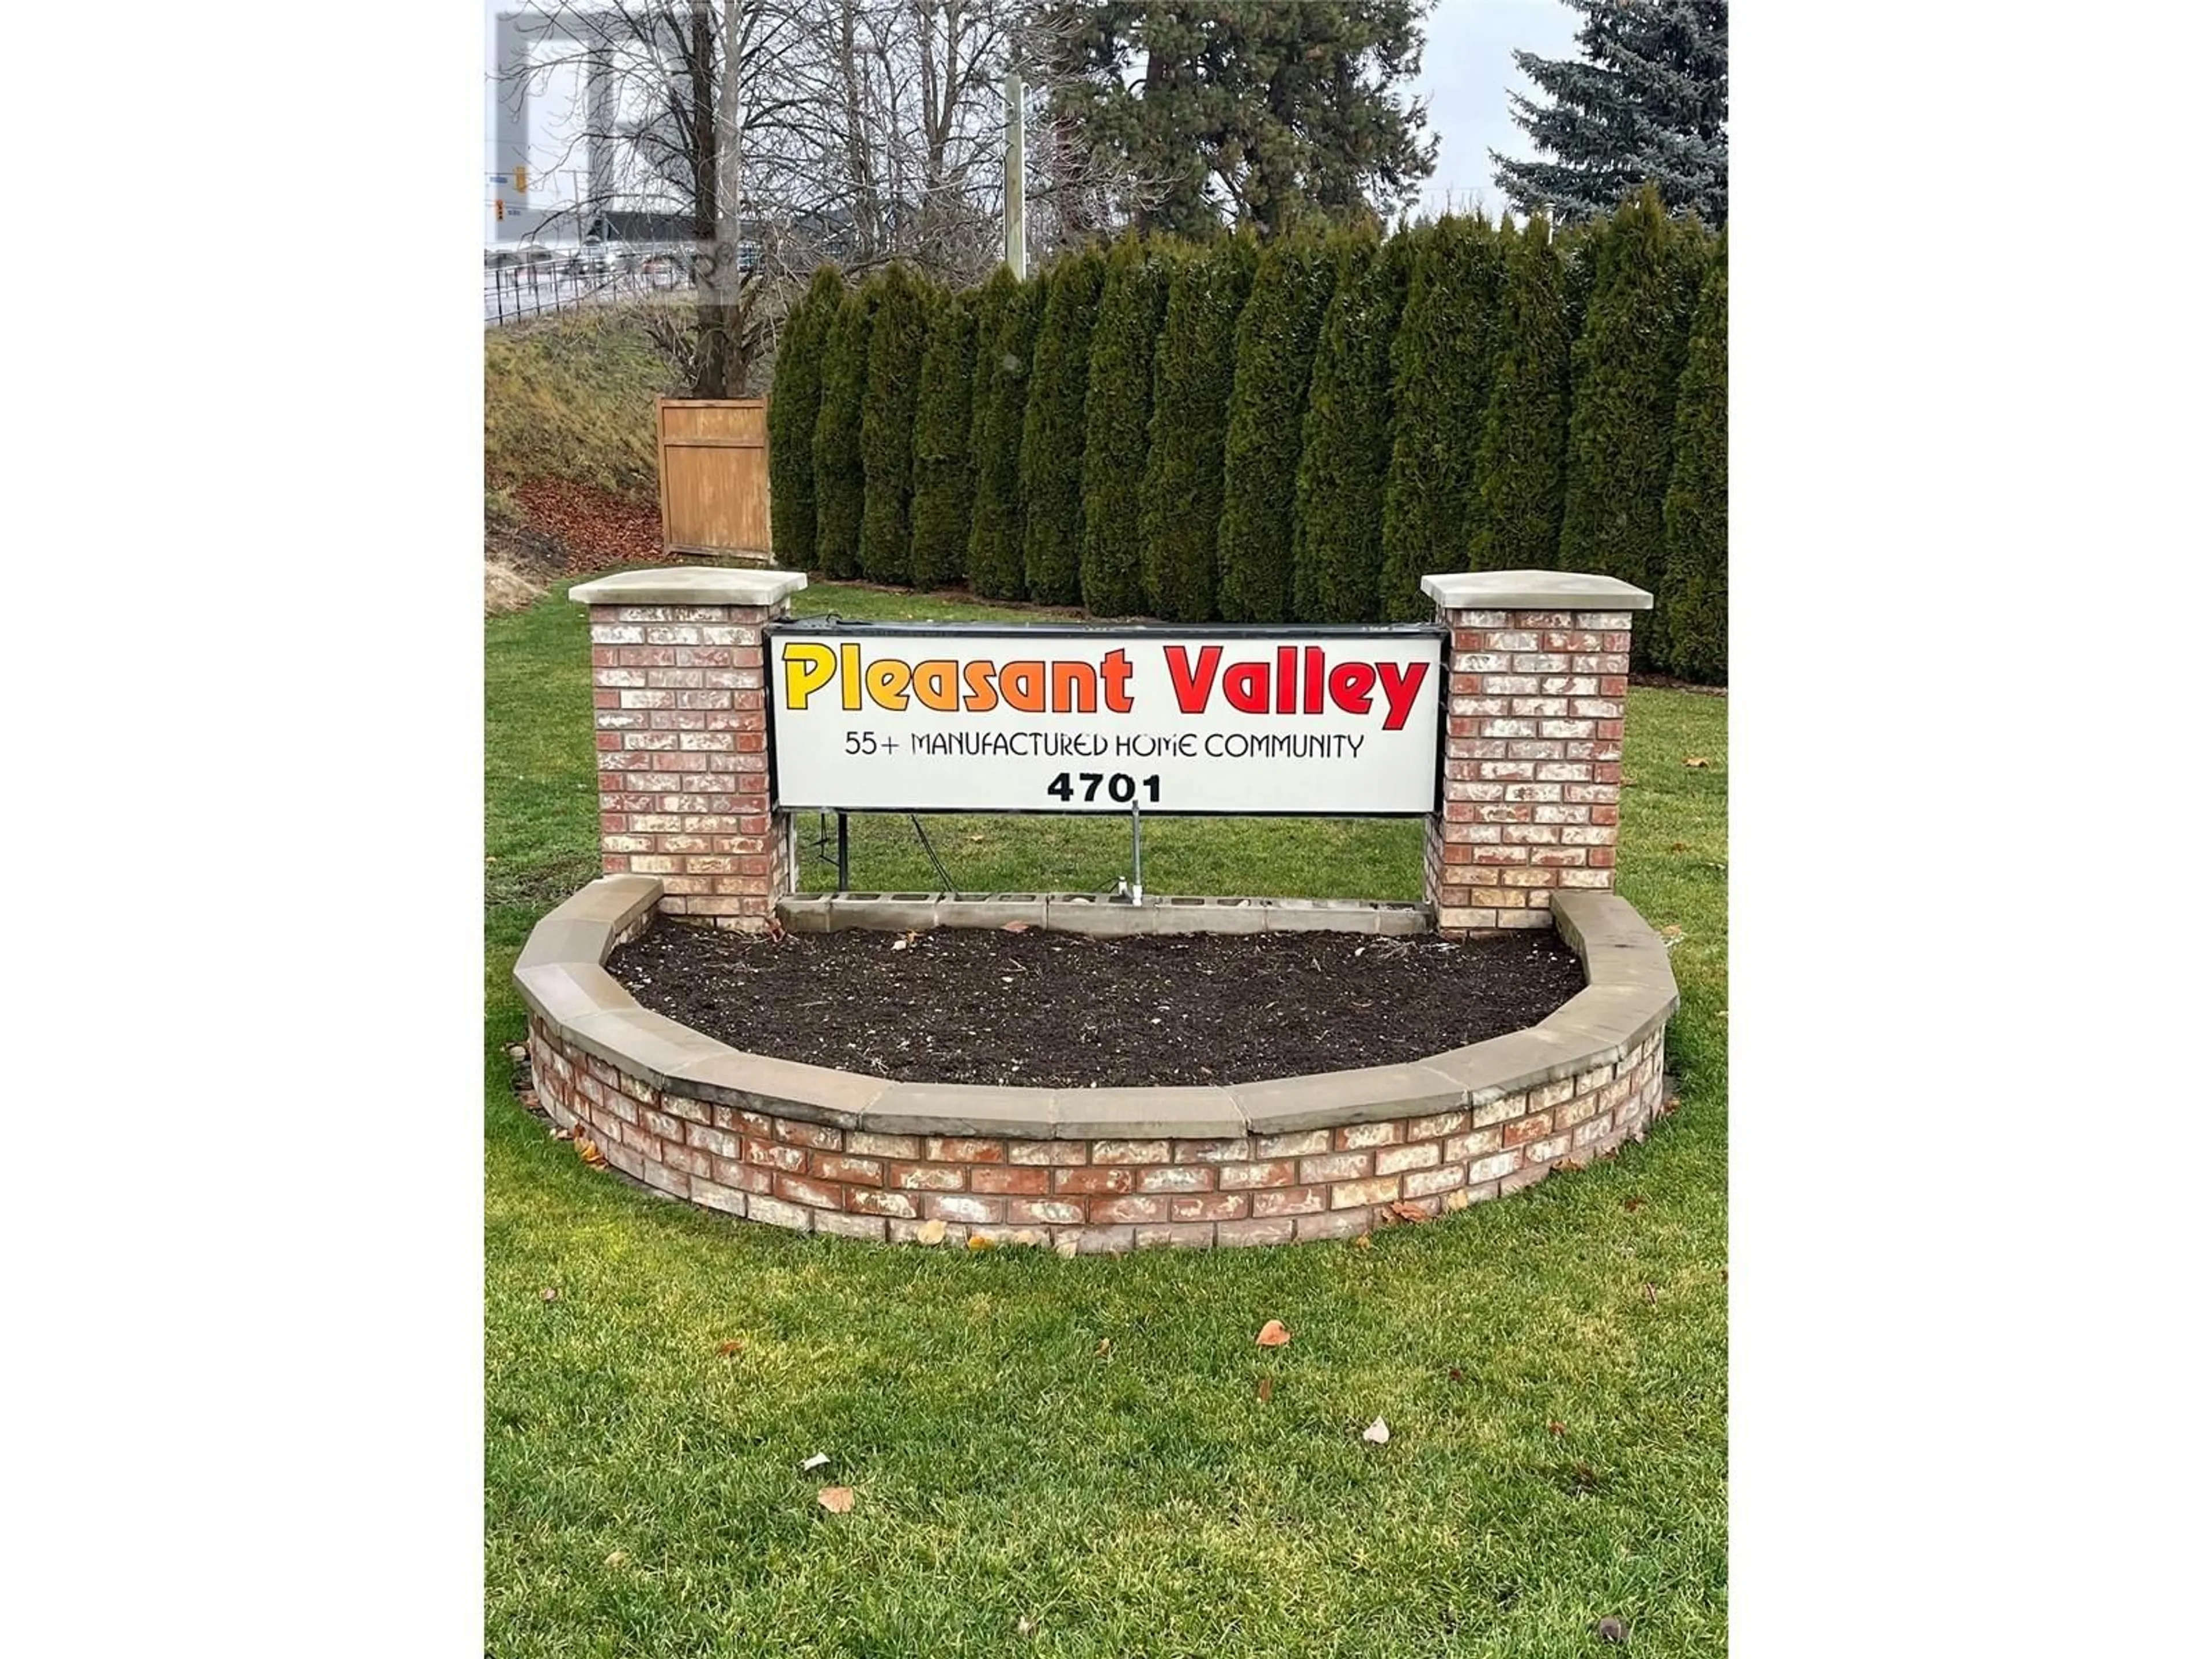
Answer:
(606, 922, 1584, 1088)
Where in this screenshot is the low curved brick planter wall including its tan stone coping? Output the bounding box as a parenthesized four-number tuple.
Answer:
(516, 876, 1677, 1252)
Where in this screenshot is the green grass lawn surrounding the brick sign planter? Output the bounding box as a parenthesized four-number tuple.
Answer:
(484, 586, 1728, 1659)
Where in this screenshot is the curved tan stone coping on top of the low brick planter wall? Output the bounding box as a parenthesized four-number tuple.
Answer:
(516, 876, 1679, 1139)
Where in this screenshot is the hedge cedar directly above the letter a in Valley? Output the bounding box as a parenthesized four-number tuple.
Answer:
(1214, 237, 1338, 622)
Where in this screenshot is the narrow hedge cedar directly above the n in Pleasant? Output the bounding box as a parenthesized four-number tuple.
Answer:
(1022, 252, 1106, 604)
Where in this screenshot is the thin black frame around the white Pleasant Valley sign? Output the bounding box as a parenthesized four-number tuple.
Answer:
(761, 617, 1451, 819)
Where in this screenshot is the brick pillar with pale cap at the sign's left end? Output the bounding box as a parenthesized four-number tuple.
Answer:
(569, 566, 808, 931)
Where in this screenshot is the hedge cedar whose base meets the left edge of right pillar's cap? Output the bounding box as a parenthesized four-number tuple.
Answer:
(1376, 214, 1509, 622)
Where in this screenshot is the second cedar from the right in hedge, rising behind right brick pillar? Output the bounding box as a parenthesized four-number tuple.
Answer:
(1559, 186, 1706, 668)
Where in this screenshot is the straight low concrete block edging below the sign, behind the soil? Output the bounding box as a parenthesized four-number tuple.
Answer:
(777, 893, 1431, 938)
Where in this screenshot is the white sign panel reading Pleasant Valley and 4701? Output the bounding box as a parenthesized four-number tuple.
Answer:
(767, 624, 1445, 814)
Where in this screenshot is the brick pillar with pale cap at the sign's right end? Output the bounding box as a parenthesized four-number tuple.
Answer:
(1420, 571, 1652, 938)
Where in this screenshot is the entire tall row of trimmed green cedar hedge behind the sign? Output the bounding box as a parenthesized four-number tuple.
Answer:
(767, 192, 1728, 681)
